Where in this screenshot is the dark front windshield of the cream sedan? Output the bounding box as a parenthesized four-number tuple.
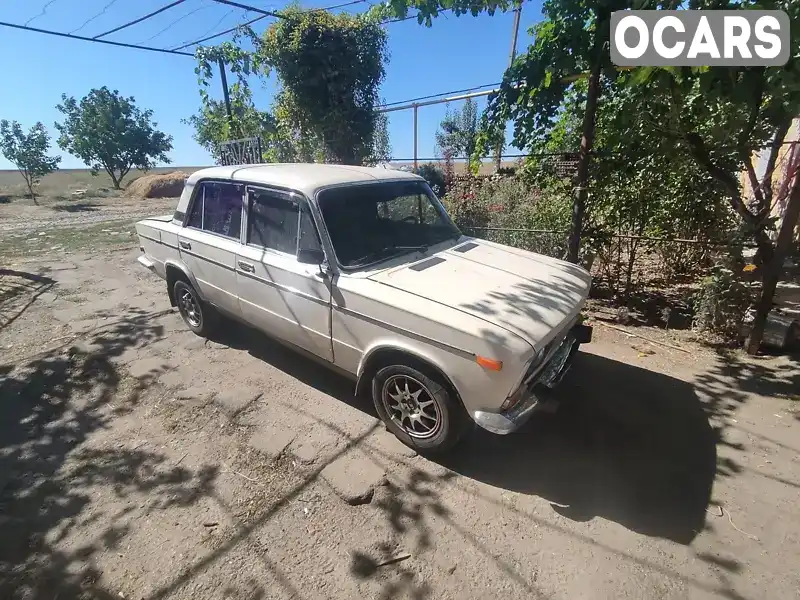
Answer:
(318, 181, 461, 268)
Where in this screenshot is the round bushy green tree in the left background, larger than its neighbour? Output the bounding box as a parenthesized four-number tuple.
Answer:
(56, 86, 172, 189)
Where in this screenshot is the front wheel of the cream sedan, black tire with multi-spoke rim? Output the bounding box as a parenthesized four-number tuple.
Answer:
(372, 365, 468, 454)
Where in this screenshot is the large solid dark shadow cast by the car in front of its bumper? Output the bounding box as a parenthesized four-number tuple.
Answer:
(442, 353, 717, 544)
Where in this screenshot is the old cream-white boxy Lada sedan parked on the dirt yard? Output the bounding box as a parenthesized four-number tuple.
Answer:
(136, 164, 591, 452)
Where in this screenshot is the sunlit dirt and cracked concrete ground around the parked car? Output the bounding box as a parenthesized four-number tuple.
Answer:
(0, 209, 800, 600)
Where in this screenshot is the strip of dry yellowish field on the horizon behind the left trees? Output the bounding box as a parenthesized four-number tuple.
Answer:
(0, 167, 203, 200)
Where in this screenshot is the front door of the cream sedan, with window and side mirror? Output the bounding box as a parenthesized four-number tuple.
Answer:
(236, 187, 333, 361)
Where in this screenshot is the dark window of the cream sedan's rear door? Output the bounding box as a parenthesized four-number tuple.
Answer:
(187, 182, 242, 239)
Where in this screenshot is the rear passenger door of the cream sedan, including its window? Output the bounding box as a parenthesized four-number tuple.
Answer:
(178, 181, 244, 315)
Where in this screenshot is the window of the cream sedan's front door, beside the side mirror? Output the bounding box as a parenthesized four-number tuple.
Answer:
(247, 190, 322, 256)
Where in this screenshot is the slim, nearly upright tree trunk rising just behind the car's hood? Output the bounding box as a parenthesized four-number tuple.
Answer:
(567, 14, 607, 263)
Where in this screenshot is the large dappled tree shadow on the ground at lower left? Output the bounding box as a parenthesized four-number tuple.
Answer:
(0, 309, 216, 600)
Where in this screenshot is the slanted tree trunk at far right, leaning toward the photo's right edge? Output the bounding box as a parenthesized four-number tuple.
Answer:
(745, 173, 800, 354)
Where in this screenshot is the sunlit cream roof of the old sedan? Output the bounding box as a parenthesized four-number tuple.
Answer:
(188, 163, 422, 197)
